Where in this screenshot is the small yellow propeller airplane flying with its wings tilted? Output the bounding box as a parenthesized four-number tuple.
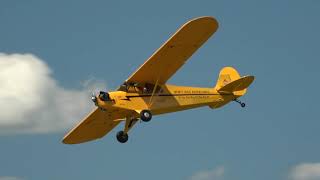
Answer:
(63, 17, 254, 144)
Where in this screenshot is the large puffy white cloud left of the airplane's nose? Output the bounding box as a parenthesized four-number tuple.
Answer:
(0, 53, 106, 134)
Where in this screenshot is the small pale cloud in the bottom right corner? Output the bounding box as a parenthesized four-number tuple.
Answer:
(289, 163, 320, 180)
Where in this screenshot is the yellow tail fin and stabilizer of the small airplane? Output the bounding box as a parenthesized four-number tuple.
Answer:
(215, 67, 254, 96)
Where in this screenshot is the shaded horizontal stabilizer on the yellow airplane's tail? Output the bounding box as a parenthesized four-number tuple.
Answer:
(218, 76, 254, 93)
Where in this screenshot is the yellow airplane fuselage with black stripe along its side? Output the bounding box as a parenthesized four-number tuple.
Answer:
(97, 84, 238, 118)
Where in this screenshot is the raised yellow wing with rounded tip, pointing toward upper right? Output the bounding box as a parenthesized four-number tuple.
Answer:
(122, 17, 218, 84)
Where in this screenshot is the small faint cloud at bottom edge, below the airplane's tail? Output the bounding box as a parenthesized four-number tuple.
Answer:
(190, 166, 225, 180)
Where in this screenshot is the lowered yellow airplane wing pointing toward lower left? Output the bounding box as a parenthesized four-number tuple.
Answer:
(62, 108, 127, 144)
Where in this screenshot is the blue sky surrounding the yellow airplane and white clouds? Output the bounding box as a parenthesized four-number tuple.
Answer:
(0, 0, 320, 180)
